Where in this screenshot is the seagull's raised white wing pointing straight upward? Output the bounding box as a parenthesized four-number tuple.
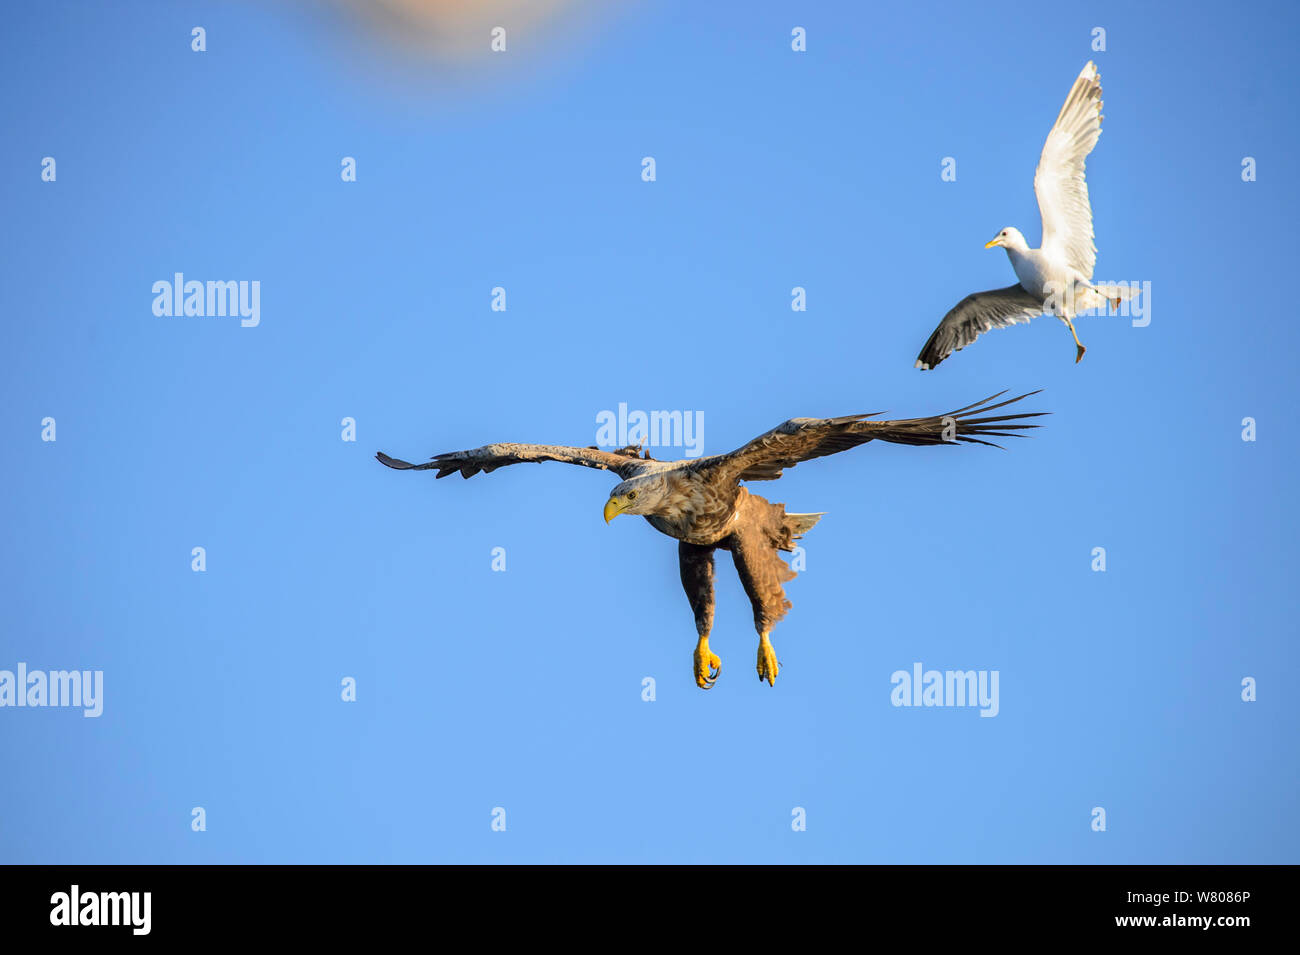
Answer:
(1034, 60, 1101, 278)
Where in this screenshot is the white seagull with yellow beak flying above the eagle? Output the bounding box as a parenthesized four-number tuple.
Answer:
(915, 60, 1139, 370)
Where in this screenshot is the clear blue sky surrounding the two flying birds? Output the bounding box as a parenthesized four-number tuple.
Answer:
(0, 3, 1300, 863)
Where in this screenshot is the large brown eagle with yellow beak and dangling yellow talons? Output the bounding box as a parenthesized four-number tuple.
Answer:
(377, 395, 1036, 689)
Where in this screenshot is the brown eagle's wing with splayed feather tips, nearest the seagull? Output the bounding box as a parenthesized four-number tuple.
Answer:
(692, 391, 1047, 481)
